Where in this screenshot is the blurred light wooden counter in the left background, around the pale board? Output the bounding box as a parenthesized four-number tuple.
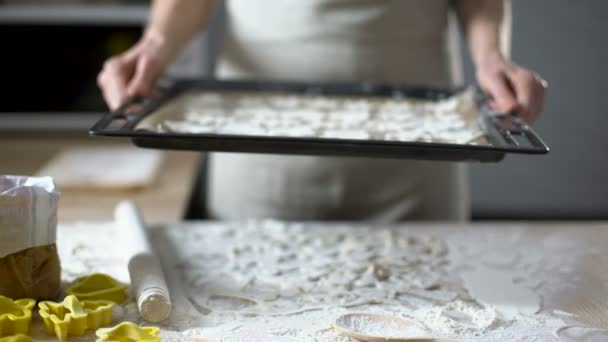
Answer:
(0, 134, 201, 223)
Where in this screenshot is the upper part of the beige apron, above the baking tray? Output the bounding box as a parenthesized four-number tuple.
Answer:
(218, 0, 451, 84)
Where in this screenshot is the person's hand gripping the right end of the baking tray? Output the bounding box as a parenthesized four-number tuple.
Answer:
(477, 54, 547, 123)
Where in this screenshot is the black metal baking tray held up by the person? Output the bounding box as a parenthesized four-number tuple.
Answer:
(90, 79, 549, 162)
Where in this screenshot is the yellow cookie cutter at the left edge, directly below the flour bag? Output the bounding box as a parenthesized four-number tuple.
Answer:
(0, 296, 36, 337)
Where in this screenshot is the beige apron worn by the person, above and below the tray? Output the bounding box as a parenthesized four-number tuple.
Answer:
(207, 0, 469, 222)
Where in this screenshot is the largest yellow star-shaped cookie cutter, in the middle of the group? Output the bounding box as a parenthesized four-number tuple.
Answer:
(38, 295, 114, 341)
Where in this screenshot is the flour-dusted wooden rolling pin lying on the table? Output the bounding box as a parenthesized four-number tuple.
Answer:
(114, 201, 171, 323)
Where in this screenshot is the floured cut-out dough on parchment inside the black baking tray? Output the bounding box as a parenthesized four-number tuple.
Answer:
(146, 91, 485, 144)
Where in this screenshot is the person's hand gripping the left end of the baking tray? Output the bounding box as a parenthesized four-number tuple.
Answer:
(97, 34, 171, 110)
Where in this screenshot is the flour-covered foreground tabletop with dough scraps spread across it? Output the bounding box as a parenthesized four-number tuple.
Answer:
(44, 221, 606, 341)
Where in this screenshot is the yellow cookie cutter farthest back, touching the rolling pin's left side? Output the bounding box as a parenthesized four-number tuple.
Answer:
(66, 273, 127, 304)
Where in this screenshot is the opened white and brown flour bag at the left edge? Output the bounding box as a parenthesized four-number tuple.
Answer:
(0, 176, 61, 299)
